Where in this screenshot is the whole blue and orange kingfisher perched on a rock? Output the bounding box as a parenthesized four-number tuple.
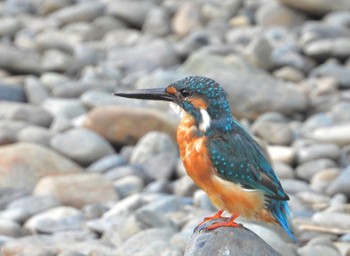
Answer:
(114, 76, 295, 241)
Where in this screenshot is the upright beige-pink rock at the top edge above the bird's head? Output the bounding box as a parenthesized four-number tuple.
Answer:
(172, 2, 202, 36)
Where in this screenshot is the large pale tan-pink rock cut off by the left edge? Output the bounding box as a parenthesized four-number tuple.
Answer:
(0, 143, 82, 190)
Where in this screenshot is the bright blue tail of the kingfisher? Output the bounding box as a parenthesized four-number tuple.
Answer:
(269, 199, 296, 241)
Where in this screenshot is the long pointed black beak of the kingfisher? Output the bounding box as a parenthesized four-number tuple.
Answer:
(114, 88, 175, 101)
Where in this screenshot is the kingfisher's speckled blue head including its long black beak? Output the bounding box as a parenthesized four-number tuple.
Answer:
(114, 76, 232, 131)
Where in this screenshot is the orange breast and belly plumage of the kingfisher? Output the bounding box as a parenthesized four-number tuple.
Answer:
(177, 114, 274, 222)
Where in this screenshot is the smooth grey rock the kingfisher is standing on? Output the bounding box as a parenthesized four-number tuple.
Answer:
(184, 220, 280, 256)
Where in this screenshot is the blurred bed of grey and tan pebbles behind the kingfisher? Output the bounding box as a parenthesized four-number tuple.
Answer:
(0, 0, 350, 256)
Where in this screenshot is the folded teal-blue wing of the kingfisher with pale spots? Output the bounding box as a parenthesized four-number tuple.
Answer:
(207, 125, 289, 200)
